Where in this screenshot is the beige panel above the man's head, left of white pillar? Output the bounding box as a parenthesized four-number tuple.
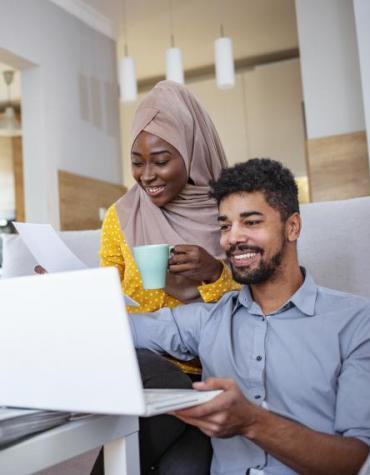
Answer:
(244, 59, 307, 176)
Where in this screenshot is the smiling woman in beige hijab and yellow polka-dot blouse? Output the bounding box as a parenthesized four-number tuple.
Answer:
(100, 81, 238, 475)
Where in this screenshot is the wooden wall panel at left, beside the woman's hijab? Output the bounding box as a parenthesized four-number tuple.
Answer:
(58, 170, 126, 230)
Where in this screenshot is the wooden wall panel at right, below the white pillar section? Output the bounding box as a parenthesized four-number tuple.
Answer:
(307, 131, 370, 201)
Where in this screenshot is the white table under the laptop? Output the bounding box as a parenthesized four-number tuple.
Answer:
(0, 416, 140, 475)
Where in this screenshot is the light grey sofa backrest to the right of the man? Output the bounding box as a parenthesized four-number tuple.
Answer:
(298, 197, 370, 298)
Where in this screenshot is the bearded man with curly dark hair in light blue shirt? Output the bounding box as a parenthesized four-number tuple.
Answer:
(130, 159, 370, 475)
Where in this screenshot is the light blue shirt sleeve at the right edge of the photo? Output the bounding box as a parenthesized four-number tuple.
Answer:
(335, 305, 370, 445)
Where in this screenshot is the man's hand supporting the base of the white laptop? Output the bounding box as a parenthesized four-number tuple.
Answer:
(173, 378, 258, 438)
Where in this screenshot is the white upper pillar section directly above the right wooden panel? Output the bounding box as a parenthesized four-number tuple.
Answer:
(296, 0, 369, 138)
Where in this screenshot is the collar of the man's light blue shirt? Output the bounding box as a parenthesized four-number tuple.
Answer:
(237, 267, 317, 317)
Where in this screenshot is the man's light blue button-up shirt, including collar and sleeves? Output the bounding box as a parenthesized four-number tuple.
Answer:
(130, 273, 370, 475)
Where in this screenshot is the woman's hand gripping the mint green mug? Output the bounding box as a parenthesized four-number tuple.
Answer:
(168, 244, 223, 285)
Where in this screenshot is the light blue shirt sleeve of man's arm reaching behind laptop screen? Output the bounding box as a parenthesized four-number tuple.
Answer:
(128, 303, 208, 360)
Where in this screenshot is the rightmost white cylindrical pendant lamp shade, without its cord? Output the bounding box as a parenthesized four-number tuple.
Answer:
(215, 37, 235, 89)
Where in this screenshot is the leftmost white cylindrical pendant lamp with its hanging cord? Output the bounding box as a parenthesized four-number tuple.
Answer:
(119, 0, 137, 103)
